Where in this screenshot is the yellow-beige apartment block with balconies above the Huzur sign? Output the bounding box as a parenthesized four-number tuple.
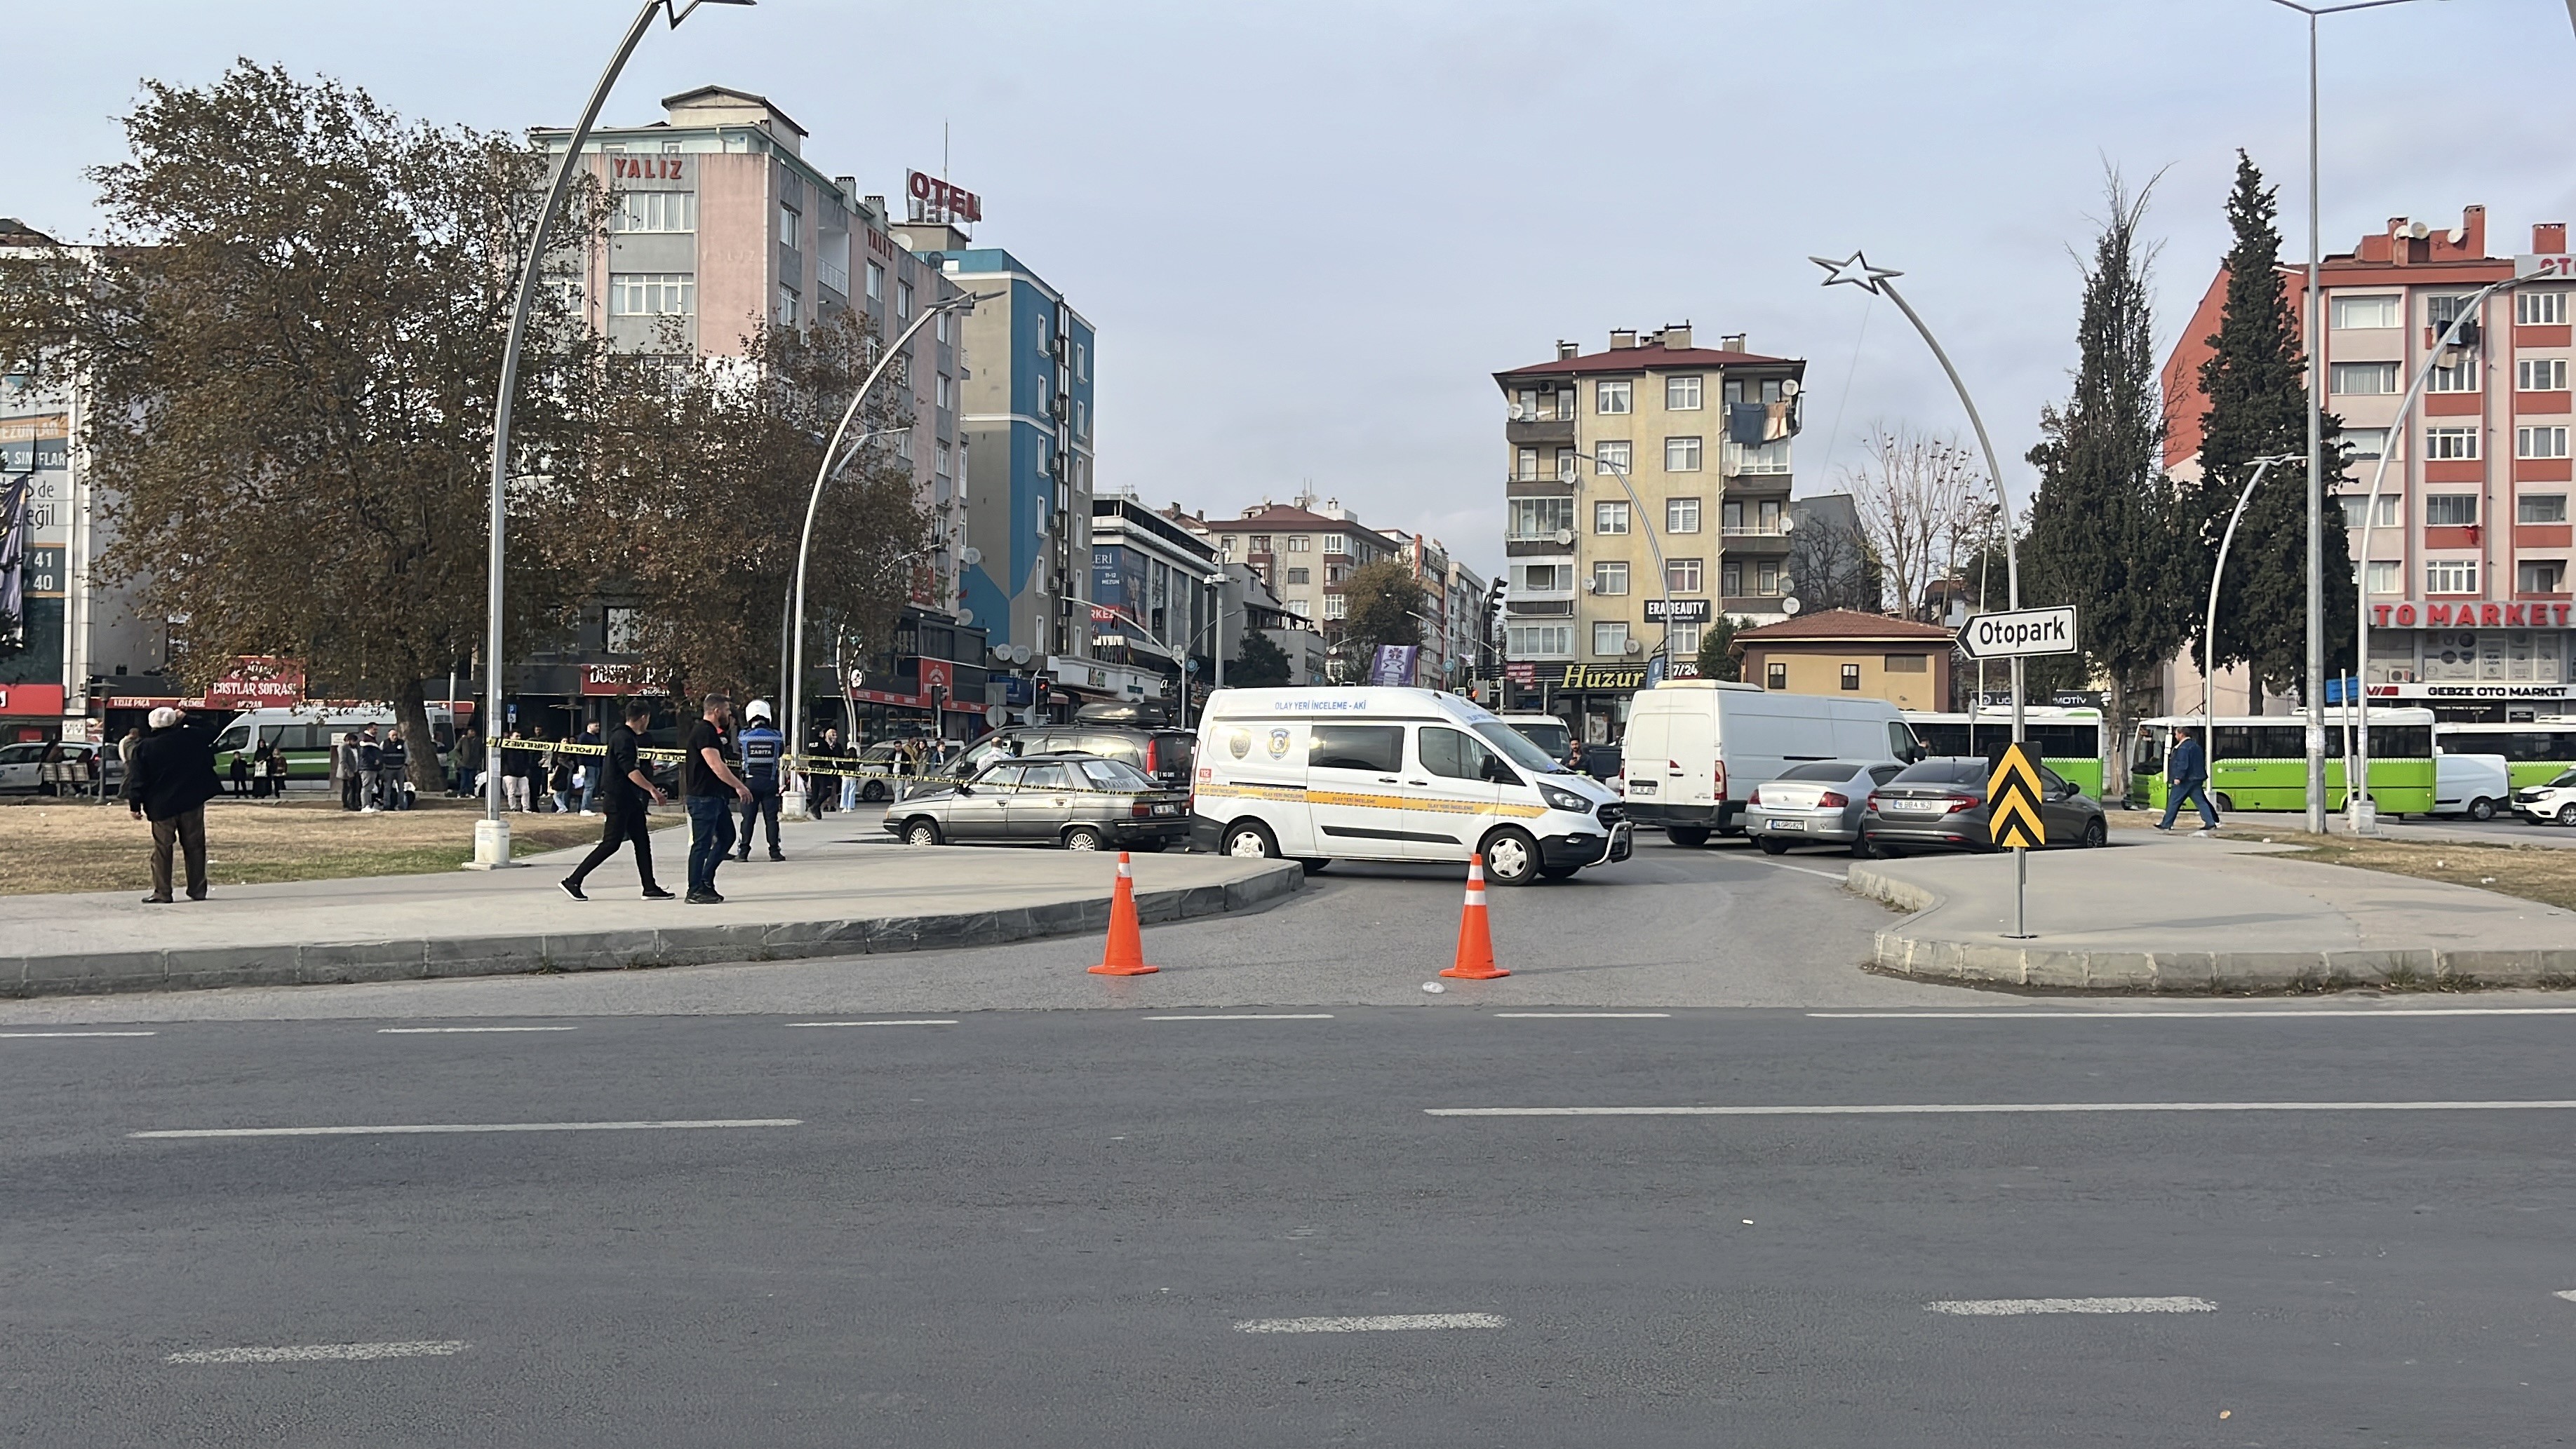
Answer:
(1494, 324, 1806, 739)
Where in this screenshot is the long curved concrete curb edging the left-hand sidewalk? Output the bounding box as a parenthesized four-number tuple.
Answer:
(0, 860, 1306, 999)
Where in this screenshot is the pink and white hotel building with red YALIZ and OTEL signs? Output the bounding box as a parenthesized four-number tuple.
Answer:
(533, 85, 981, 625)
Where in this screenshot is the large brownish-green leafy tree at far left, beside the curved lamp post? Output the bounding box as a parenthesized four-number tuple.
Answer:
(0, 62, 598, 788)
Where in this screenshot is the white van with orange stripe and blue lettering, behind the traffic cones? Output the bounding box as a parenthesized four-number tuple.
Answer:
(1190, 687, 1628, 885)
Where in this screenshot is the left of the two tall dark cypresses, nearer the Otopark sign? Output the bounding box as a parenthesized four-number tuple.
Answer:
(2022, 173, 2200, 793)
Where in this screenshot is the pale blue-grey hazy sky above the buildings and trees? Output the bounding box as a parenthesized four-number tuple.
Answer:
(20, 0, 2576, 569)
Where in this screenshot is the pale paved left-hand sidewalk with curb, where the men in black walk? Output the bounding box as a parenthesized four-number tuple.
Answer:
(15, 814, 1303, 996)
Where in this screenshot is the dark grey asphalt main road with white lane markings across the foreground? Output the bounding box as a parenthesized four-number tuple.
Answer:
(0, 996, 2576, 1449)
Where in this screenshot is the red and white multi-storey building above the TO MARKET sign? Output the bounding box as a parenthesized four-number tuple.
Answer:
(2164, 206, 2576, 720)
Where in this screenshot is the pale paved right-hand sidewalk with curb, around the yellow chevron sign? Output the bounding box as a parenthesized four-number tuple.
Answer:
(1849, 834, 2576, 993)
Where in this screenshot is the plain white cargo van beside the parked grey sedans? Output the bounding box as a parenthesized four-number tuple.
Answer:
(1625, 680, 1921, 844)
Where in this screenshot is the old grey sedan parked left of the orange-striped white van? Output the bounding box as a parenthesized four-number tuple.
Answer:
(886, 752, 1190, 849)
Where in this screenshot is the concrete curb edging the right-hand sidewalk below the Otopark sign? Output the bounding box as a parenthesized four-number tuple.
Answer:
(1847, 865, 2576, 996)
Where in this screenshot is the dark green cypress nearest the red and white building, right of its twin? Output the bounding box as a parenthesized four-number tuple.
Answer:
(2192, 152, 2354, 689)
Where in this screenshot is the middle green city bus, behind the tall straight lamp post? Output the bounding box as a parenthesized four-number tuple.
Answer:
(2128, 705, 2434, 816)
